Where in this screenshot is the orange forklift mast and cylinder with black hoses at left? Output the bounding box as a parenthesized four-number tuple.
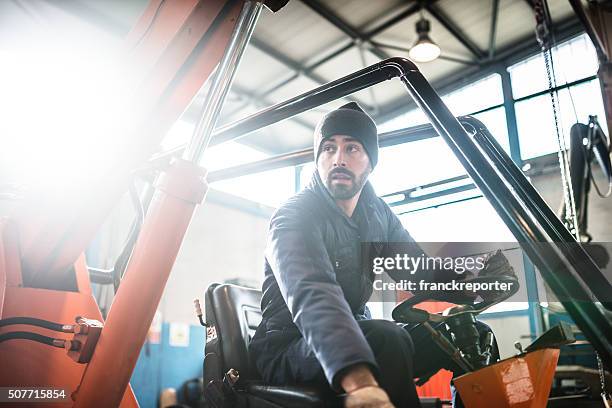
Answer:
(0, 0, 253, 407)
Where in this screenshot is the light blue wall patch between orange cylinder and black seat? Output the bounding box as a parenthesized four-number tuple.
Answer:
(130, 323, 206, 408)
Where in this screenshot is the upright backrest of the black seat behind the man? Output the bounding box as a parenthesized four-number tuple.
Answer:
(207, 284, 261, 379)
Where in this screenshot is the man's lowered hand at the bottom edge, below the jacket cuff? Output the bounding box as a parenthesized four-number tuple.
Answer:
(340, 364, 394, 408)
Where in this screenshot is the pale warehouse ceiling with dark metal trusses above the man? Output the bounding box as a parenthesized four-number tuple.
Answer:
(0, 0, 580, 157)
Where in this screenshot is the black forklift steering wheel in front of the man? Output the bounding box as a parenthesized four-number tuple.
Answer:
(391, 275, 519, 323)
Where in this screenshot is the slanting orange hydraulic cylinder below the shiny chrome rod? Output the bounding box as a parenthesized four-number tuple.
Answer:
(72, 159, 207, 408)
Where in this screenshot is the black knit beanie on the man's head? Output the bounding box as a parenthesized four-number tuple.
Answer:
(314, 102, 378, 168)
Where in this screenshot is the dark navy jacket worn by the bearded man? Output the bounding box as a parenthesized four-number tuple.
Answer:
(250, 171, 422, 386)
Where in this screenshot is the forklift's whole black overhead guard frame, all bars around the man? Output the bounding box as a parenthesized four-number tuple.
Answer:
(202, 58, 612, 367)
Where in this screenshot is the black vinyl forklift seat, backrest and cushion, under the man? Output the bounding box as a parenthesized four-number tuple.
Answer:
(204, 284, 342, 408)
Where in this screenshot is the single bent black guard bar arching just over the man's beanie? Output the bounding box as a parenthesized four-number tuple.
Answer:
(176, 58, 612, 364)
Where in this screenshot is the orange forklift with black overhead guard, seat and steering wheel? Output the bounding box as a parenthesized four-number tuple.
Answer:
(0, 0, 612, 408)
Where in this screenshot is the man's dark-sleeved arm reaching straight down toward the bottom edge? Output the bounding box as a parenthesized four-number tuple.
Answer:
(266, 206, 378, 389)
